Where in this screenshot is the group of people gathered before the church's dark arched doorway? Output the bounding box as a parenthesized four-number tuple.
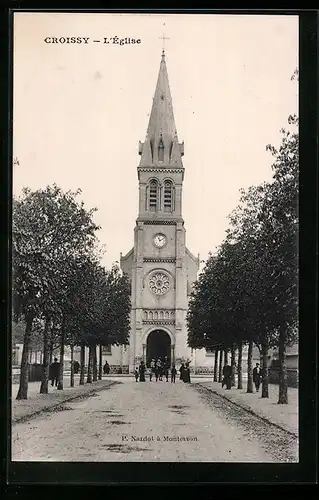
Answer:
(134, 357, 191, 384)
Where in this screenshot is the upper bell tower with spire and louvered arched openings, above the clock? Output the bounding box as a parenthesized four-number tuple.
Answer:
(137, 50, 184, 222)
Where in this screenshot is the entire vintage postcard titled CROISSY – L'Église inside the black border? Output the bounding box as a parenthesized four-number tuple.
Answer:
(11, 11, 299, 464)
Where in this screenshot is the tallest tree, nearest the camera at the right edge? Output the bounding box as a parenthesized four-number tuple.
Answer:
(265, 115, 299, 404)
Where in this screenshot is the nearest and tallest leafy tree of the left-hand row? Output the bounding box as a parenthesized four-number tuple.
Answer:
(13, 185, 98, 399)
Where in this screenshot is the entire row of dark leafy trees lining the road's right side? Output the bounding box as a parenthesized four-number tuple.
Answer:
(188, 108, 299, 403)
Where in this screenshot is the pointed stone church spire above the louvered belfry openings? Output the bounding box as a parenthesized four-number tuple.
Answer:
(139, 50, 184, 168)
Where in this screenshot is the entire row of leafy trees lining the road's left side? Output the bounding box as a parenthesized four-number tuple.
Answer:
(12, 185, 131, 399)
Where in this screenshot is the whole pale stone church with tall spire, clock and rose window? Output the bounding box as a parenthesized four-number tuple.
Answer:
(105, 50, 213, 373)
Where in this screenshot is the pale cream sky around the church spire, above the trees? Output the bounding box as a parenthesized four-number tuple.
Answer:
(13, 12, 298, 267)
